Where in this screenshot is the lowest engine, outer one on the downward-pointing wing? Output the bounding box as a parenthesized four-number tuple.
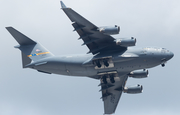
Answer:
(124, 84, 143, 94)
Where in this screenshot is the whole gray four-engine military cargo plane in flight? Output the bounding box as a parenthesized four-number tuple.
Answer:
(6, 1, 174, 114)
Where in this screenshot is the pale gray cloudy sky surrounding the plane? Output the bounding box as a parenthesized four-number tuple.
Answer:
(0, 0, 180, 115)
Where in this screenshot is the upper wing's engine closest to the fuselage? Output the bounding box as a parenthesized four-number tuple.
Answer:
(116, 37, 136, 47)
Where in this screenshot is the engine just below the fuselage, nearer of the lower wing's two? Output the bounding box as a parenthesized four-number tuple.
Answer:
(129, 70, 149, 78)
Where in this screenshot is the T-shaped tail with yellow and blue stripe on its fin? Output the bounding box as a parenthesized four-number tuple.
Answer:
(6, 27, 53, 68)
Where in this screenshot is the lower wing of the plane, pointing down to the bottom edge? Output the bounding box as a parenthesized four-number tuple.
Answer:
(100, 75, 128, 114)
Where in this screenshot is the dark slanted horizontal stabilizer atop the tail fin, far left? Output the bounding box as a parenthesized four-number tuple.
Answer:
(6, 27, 36, 45)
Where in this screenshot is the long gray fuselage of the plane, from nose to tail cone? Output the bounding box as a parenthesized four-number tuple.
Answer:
(28, 47, 173, 79)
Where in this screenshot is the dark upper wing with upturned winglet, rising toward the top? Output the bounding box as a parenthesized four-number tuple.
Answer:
(61, 1, 126, 54)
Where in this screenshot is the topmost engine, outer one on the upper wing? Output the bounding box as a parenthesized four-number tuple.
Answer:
(98, 25, 120, 35)
